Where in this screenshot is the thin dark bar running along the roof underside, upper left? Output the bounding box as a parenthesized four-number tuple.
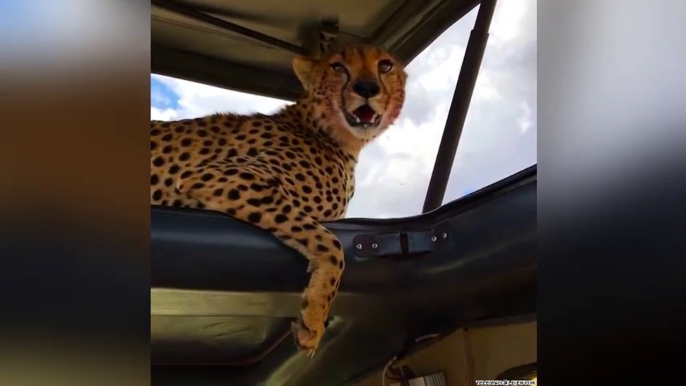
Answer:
(152, 0, 304, 55)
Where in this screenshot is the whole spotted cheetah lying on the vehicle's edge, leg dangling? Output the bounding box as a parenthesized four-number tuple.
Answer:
(150, 45, 407, 357)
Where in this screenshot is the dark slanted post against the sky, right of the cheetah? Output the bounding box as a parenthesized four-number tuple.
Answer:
(423, 0, 496, 213)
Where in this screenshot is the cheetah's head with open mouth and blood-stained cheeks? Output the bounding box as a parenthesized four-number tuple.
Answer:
(294, 46, 407, 139)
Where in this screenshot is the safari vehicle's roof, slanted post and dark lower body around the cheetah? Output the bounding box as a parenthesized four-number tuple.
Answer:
(151, 0, 537, 386)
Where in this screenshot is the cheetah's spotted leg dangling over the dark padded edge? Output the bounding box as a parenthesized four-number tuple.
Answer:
(177, 164, 345, 356)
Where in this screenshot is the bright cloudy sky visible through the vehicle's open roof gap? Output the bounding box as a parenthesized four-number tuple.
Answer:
(151, 0, 537, 218)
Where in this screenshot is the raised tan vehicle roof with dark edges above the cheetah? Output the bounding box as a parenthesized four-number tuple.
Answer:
(151, 0, 480, 101)
